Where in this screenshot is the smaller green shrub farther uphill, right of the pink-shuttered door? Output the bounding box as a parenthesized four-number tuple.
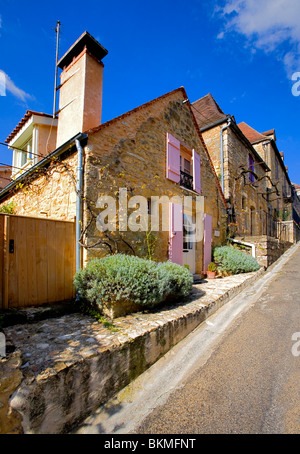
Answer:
(213, 246, 260, 274)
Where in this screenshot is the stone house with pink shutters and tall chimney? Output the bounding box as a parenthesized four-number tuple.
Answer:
(0, 32, 227, 274)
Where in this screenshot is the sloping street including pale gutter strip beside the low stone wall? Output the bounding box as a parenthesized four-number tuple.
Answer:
(78, 247, 300, 434)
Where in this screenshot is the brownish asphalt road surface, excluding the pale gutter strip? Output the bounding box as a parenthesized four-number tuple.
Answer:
(137, 248, 300, 434)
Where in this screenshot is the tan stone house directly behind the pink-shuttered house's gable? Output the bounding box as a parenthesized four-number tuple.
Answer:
(192, 93, 270, 236)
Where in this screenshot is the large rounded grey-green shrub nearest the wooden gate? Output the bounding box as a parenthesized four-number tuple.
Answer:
(74, 254, 193, 312)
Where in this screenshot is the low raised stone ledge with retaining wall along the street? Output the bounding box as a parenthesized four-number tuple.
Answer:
(3, 268, 265, 433)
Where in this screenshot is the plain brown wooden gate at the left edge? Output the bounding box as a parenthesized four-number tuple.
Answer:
(0, 214, 75, 309)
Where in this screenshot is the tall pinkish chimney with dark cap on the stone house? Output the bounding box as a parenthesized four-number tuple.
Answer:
(56, 32, 108, 147)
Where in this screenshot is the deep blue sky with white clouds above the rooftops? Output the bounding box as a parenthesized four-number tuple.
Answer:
(0, 0, 300, 184)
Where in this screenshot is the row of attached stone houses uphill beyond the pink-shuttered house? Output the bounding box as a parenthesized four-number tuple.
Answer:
(192, 94, 297, 266)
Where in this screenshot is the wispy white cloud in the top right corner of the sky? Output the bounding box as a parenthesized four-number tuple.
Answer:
(217, 0, 300, 74)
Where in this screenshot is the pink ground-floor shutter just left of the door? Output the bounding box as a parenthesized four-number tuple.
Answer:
(169, 203, 183, 265)
